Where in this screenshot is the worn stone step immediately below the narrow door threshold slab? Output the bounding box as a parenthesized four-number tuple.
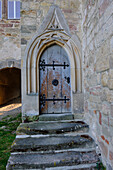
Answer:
(16, 121, 89, 135)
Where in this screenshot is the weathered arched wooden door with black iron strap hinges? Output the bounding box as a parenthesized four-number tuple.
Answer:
(39, 44, 71, 114)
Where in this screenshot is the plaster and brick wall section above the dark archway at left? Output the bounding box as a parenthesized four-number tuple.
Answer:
(0, 0, 21, 69)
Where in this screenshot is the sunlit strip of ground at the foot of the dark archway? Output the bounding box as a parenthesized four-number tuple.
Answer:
(0, 98, 22, 120)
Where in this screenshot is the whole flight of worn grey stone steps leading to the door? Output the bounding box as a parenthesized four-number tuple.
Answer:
(6, 114, 99, 170)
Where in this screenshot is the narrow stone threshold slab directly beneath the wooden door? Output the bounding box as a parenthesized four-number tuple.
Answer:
(39, 113, 74, 121)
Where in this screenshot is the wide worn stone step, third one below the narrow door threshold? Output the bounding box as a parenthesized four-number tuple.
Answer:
(7, 151, 98, 170)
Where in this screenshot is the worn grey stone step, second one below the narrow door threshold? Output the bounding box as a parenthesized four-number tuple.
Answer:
(12, 135, 95, 152)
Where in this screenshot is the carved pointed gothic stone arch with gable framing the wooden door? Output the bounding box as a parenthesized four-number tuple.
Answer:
(22, 6, 82, 117)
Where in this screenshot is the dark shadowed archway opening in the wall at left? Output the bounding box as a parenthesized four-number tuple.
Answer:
(0, 68, 21, 105)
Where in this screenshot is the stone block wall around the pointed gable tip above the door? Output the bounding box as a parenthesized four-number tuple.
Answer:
(21, 0, 82, 49)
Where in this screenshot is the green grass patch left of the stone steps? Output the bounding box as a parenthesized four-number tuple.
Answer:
(0, 114, 21, 170)
